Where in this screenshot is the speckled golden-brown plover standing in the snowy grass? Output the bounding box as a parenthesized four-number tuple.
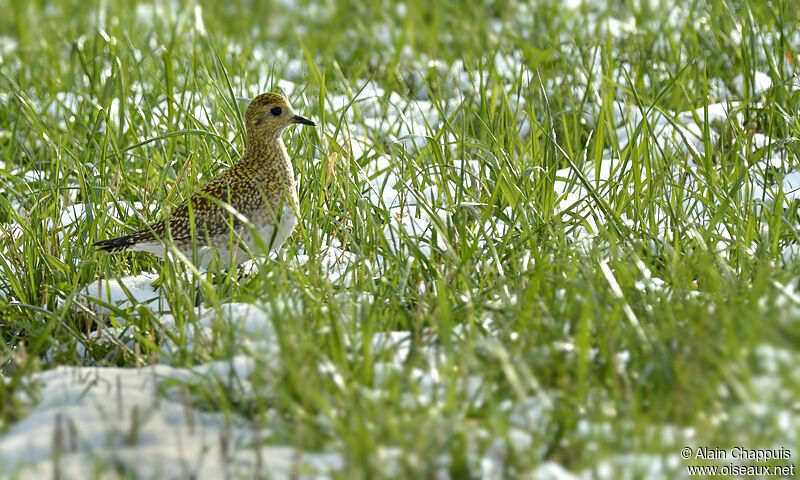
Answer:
(93, 93, 316, 266)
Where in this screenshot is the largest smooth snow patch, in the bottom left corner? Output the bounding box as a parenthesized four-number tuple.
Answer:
(0, 357, 343, 479)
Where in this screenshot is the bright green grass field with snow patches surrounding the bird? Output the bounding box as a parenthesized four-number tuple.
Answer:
(0, 0, 800, 478)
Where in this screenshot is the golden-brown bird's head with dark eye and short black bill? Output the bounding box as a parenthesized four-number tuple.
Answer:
(245, 93, 317, 139)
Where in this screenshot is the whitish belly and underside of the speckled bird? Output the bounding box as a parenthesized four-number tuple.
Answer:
(129, 205, 297, 268)
